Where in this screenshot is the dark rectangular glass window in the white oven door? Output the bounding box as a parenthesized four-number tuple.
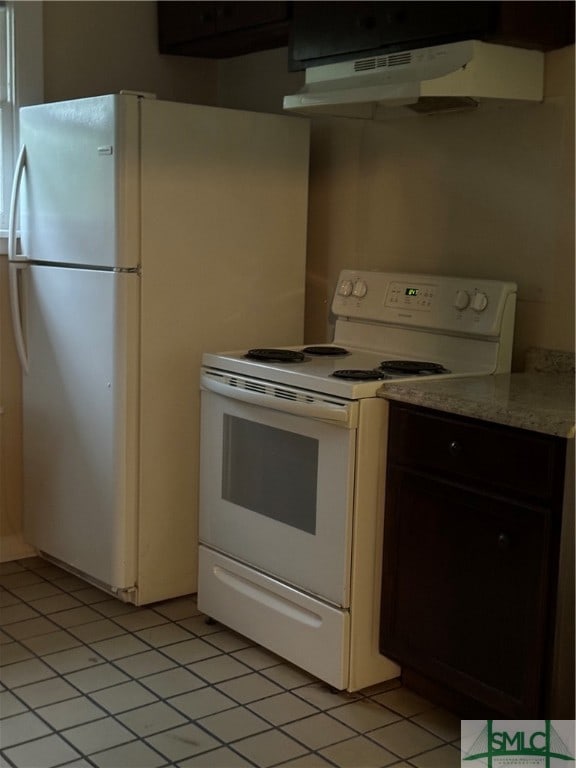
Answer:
(222, 414, 318, 534)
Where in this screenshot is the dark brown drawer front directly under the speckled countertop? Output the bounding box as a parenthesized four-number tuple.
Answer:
(389, 402, 563, 499)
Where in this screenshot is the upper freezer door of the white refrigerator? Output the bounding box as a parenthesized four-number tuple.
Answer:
(20, 95, 139, 268)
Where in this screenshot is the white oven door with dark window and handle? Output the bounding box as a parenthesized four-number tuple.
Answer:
(200, 371, 358, 608)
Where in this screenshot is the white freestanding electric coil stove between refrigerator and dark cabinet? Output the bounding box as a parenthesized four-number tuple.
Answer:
(198, 270, 516, 690)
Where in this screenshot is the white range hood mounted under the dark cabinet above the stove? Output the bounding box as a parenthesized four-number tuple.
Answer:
(284, 40, 544, 120)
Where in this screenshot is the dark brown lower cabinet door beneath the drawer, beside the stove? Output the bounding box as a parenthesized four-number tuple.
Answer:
(380, 466, 551, 717)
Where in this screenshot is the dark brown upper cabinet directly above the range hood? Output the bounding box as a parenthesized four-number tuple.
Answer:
(289, 0, 574, 70)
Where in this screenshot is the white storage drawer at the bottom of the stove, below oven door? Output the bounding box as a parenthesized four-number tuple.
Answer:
(198, 546, 350, 690)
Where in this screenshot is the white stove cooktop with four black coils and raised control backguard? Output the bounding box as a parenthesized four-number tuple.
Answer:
(203, 270, 516, 399)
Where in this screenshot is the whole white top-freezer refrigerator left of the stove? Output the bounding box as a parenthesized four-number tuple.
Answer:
(9, 94, 309, 604)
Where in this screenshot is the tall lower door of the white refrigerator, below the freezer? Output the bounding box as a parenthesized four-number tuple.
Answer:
(23, 266, 140, 592)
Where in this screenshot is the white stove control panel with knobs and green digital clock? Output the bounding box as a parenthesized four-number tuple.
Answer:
(332, 270, 517, 336)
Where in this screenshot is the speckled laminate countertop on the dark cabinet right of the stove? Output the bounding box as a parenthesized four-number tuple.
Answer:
(378, 373, 575, 438)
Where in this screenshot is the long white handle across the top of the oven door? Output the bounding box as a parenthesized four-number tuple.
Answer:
(200, 373, 358, 429)
